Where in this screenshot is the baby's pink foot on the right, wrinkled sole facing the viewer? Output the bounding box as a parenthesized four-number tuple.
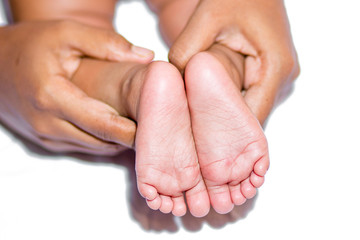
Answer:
(185, 47, 269, 213)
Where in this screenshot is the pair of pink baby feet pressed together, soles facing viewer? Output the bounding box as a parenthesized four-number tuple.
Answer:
(135, 45, 269, 217)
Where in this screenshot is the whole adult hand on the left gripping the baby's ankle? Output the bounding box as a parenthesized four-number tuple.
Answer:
(0, 21, 153, 155)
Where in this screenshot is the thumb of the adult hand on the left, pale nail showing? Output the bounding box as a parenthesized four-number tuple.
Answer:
(60, 21, 154, 63)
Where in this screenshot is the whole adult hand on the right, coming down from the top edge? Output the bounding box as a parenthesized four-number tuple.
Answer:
(169, 0, 299, 124)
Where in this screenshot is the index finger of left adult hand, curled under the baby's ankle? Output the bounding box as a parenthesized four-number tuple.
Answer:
(39, 77, 136, 147)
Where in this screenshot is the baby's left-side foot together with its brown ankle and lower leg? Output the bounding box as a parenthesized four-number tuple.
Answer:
(73, 60, 210, 217)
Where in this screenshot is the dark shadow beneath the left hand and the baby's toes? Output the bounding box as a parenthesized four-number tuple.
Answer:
(11, 131, 257, 232)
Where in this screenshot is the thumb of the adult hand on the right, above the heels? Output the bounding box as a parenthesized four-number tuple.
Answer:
(168, 11, 218, 72)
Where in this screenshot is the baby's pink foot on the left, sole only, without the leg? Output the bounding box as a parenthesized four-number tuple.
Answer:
(135, 62, 210, 217)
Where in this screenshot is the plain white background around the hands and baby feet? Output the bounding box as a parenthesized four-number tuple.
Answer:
(0, 0, 360, 240)
